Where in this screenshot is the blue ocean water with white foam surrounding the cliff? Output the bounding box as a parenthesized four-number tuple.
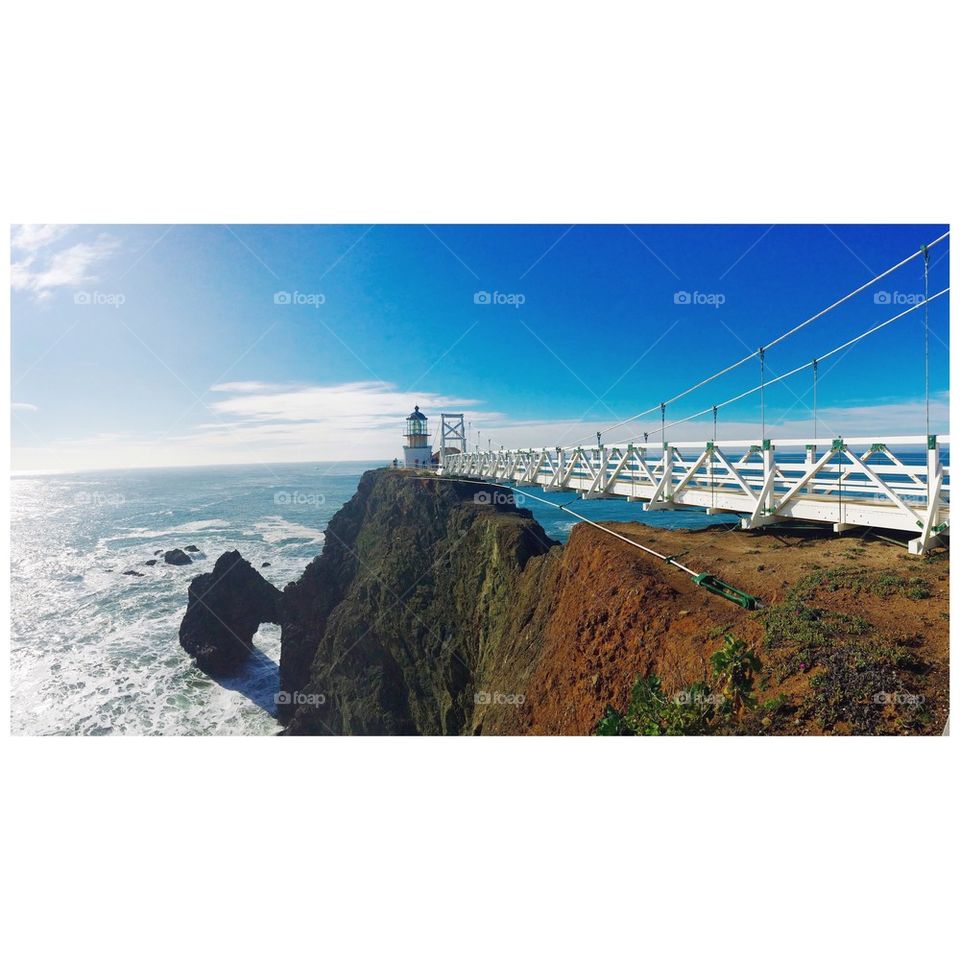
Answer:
(11, 462, 734, 735)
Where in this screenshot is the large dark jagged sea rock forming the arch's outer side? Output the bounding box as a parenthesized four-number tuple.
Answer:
(180, 550, 283, 675)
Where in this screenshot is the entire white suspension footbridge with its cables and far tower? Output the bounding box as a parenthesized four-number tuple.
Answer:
(438, 232, 950, 554)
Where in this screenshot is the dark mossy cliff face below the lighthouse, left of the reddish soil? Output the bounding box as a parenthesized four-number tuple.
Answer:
(280, 470, 560, 734)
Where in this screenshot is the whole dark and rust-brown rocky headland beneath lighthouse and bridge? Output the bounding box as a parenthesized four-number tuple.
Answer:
(185, 470, 948, 735)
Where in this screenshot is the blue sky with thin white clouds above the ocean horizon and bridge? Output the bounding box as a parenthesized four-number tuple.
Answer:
(12, 224, 949, 470)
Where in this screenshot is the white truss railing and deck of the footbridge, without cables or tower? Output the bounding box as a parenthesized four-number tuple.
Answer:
(441, 436, 950, 552)
